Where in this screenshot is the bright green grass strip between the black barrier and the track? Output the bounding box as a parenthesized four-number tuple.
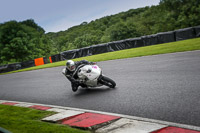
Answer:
(1, 38, 200, 74)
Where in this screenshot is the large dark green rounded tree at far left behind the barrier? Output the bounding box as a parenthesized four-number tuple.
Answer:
(0, 19, 51, 64)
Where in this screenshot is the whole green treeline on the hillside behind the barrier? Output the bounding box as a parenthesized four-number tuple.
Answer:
(0, 0, 200, 64)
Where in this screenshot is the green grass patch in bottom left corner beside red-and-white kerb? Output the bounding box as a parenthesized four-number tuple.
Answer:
(0, 105, 89, 133)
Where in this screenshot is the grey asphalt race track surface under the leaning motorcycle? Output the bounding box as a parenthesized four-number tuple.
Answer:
(0, 51, 200, 126)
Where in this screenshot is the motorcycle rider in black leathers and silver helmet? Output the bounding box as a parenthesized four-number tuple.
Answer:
(63, 60, 96, 92)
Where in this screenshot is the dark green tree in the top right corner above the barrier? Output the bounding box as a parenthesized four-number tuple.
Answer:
(160, 0, 200, 29)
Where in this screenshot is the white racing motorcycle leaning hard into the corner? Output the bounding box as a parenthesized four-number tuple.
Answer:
(63, 65, 116, 91)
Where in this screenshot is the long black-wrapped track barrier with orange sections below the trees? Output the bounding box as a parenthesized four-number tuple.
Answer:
(0, 25, 200, 73)
